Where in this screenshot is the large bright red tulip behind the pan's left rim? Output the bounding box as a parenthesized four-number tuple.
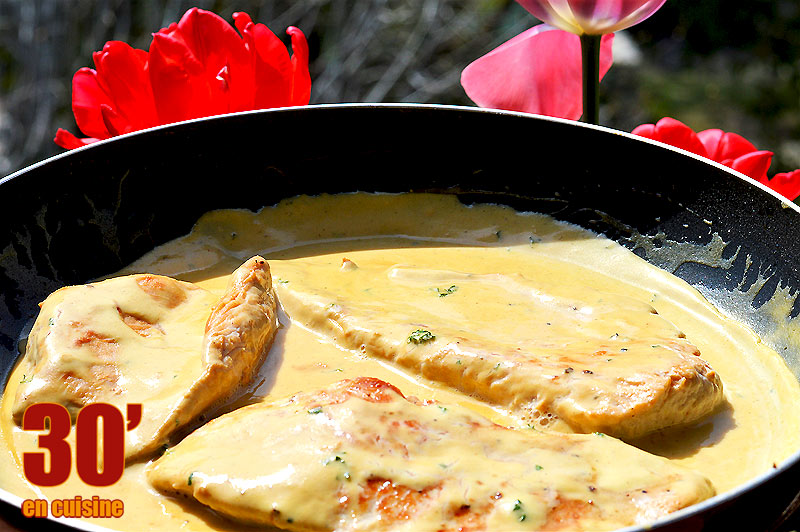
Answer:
(55, 8, 311, 149)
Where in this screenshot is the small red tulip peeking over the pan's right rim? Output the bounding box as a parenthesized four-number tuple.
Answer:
(633, 117, 800, 200)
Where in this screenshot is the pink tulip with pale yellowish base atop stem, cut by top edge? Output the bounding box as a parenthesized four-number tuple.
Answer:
(517, 0, 666, 35)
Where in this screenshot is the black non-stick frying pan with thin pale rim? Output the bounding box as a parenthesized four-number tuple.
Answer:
(0, 104, 800, 531)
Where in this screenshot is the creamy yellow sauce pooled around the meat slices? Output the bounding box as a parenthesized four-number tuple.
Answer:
(0, 194, 800, 530)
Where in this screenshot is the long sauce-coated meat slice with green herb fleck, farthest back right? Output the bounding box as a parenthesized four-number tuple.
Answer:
(277, 257, 723, 439)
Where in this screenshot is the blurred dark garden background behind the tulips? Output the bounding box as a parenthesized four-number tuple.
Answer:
(0, 0, 800, 176)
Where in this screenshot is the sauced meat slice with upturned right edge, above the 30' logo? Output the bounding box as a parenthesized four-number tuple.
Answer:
(7, 257, 277, 459)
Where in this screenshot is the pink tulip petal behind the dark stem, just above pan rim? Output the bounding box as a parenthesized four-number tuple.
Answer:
(461, 24, 614, 120)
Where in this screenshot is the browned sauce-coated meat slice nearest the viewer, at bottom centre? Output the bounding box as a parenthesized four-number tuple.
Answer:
(147, 377, 714, 531)
